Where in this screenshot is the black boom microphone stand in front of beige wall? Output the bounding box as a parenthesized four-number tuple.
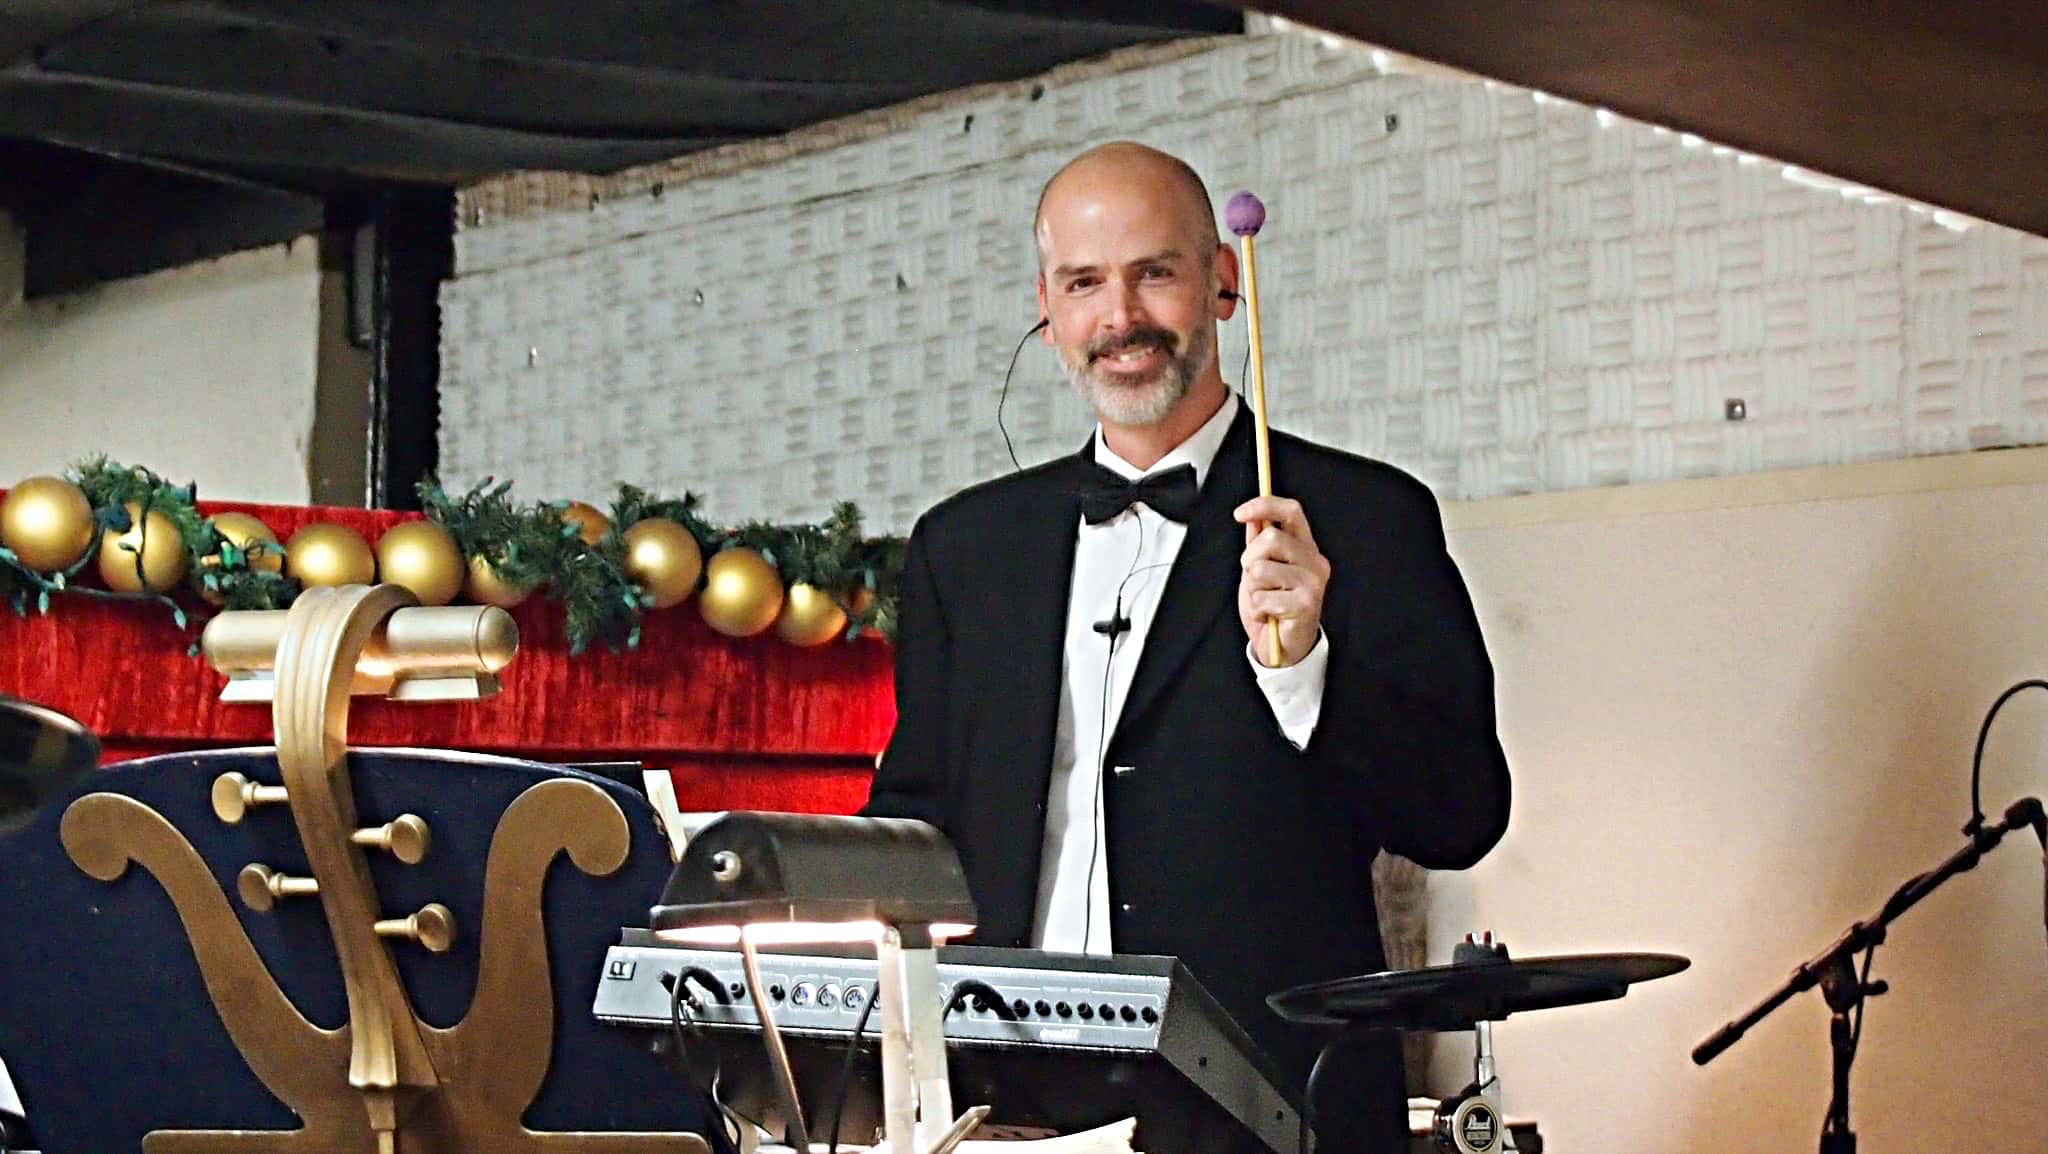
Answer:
(1692, 797, 2048, 1154)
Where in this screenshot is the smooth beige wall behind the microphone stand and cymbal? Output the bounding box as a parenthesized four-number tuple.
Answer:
(1430, 451, 2048, 1154)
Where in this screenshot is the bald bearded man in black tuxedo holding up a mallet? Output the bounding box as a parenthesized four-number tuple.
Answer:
(866, 143, 1509, 1154)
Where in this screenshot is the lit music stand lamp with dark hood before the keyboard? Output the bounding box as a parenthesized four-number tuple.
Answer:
(649, 812, 987, 1154)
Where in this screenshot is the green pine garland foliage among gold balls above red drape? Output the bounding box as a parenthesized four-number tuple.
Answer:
(0, 457, 903, 654)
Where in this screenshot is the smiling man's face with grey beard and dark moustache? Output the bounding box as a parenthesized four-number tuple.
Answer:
(1038, 174, 1217, 426)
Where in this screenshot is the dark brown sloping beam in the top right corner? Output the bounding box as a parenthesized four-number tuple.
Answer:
(1257, 0, 2048, 236)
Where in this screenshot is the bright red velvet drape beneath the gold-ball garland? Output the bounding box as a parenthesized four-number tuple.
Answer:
(0, 502, 895, 812)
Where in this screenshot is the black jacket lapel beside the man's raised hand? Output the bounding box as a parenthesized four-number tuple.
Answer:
(1114, 406, 1257, 752)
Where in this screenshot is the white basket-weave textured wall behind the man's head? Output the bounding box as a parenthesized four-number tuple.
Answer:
(442, 35, 2048, 531)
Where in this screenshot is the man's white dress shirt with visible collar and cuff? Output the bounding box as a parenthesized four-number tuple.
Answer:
(1032, 394, 1329, 953)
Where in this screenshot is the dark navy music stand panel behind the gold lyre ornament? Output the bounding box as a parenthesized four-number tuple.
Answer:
(0, 746, 719, 1154)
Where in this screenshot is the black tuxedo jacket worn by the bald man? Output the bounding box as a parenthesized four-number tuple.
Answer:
(866, 410, 1509, 1148)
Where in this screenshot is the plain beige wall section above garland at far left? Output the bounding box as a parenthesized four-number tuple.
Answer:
(0, 223, 319, 504)
